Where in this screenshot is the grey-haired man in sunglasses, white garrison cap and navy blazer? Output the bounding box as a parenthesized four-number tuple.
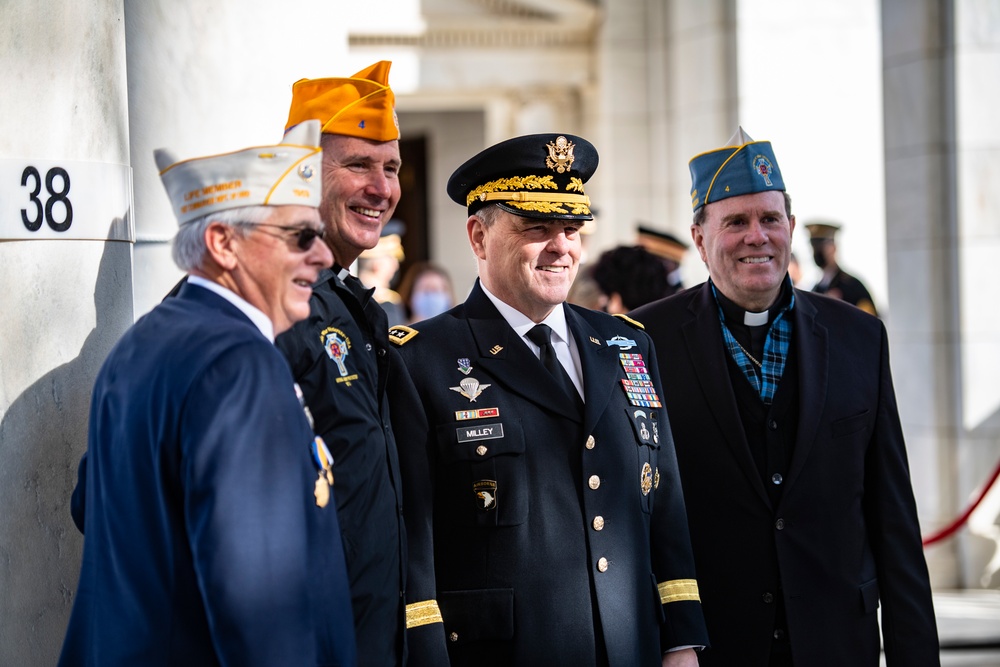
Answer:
(59, 122, 356, 667)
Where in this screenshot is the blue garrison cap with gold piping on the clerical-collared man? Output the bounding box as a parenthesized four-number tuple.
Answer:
(688, 127, 785, 211)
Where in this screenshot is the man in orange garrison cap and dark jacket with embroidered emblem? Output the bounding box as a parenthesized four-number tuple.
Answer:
(276, 61, 404, 667)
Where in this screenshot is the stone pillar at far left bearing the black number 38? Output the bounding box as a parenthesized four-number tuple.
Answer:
(0, 0, 133, 666)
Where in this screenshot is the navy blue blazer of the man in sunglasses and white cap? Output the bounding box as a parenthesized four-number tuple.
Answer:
(59, 284, 356, 667)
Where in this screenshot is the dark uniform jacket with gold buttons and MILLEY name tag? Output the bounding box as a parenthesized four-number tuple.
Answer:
(390, 283, 707, 667)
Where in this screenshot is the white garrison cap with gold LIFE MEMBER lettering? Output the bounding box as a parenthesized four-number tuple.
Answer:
(153, 120, 323, 225)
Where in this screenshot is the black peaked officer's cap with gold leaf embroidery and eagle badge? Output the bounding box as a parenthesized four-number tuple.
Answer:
(448, 134, 598, 220)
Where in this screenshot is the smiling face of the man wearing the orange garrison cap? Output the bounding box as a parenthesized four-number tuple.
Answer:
(319, 134, 401, 266)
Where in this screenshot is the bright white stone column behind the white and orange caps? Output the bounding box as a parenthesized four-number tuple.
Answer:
(125, 0, 348, 315)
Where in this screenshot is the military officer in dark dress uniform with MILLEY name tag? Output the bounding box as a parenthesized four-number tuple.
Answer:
(390, 134, 708, 667)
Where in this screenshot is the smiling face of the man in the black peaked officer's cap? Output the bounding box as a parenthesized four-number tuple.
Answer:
(468, 209, 583, 322)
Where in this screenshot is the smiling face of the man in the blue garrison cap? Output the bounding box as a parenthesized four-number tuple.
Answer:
(691, 190, 795, 312)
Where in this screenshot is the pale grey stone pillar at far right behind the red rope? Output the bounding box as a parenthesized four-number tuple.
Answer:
(882, 0, 1000, 588)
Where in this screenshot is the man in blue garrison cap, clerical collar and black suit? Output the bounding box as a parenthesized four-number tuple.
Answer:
(632, 129, 938, 667)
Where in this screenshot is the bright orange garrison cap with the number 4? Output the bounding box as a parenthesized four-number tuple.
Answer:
(285, 60, 399, 141)
